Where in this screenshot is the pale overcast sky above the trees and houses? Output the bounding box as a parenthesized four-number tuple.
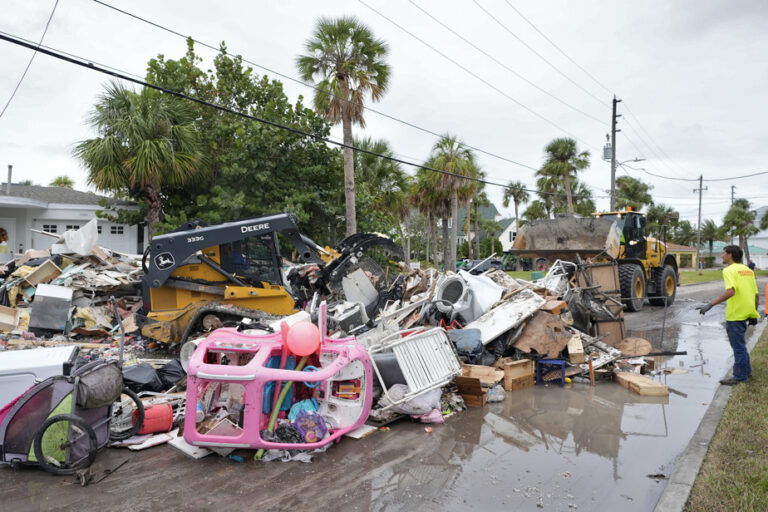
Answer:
(0, 0, 768, 223)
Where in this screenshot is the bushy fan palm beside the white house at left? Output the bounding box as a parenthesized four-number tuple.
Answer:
(74, 83, 202, 240)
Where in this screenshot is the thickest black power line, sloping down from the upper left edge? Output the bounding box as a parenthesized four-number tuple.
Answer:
(0, 32, 592, 204)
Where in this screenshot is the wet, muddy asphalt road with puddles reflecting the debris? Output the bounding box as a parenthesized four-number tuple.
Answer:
(0, 278, 766, 512)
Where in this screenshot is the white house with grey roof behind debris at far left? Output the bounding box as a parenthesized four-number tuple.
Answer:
(0, 183, 146, 262)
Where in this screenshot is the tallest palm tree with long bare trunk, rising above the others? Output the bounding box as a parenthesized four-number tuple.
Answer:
(296, 16, 390, 236)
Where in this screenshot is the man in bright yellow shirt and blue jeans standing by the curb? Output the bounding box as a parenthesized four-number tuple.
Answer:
(696, 245, 760, 386)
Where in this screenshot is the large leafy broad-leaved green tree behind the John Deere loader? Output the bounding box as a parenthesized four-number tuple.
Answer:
(147, 41, 344, 244)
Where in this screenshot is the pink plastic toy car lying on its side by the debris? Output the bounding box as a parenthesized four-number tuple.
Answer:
(184, 303, 373, 450)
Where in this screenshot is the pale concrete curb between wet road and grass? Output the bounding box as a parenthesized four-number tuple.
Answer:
(653, 322, 768, 512)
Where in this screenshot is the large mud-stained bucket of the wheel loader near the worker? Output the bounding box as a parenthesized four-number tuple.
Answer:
(513, 216, 621, 260)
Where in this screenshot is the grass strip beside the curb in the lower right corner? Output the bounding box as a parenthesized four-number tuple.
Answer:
(685, 329, 768, 512)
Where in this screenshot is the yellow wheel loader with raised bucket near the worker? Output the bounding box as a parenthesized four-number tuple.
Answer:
(510, 209, 679, 311)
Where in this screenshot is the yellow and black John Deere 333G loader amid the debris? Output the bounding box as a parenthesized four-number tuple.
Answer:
(137, 213, 403, 344)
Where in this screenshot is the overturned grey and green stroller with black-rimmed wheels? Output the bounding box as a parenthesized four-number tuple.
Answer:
(0, 298, 144, 475)
